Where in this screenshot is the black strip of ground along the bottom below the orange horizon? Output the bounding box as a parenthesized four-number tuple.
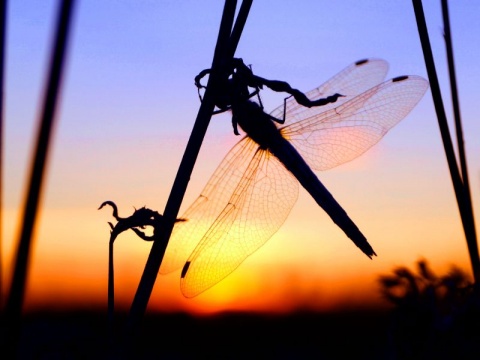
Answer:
(2, 311, 480, 360)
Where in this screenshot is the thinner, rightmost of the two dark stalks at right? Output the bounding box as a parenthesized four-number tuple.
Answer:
(442, 0, 478, 239)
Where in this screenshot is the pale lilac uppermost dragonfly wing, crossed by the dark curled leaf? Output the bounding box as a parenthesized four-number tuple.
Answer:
(271, 59, 388, 124)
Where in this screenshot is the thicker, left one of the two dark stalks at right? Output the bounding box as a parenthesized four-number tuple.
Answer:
(412, 0, 480, 283)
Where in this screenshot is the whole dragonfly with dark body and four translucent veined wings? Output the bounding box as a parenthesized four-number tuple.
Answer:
(160, 59, 428, 297)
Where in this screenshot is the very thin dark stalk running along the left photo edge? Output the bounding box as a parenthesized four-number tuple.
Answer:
(0, 0, 7, 314)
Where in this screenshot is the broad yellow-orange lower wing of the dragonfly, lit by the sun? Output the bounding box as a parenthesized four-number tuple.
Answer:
(181, 149, 298, 297)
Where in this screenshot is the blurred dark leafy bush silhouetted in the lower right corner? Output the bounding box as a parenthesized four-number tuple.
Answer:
(379, 260, 480, 359)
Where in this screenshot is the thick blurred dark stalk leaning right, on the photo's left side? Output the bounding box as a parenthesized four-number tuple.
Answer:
(3, 0, 74, 351)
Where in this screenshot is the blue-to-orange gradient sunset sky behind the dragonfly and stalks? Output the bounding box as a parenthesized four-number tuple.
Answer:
(2, 0, 480, 313)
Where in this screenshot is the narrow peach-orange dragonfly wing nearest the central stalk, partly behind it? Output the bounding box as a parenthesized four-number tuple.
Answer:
(160, 137, 258, 274)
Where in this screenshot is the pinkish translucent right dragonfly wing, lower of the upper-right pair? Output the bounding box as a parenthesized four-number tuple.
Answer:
(281, 76, 428, 170)
